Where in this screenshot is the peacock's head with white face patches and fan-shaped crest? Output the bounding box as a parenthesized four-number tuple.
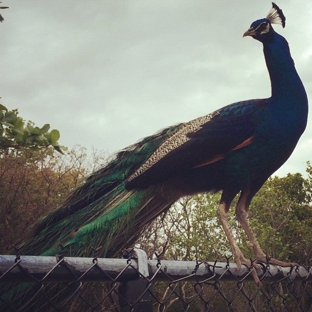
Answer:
(243, 2, 286, 42)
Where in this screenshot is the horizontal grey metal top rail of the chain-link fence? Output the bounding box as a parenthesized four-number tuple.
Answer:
(0, 255, 312, 283)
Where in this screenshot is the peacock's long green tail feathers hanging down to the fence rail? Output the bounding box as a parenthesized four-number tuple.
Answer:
(20, 126, 179, 257)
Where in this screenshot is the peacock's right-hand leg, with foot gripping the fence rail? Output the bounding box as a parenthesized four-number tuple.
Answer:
(236, 189, 298, 267)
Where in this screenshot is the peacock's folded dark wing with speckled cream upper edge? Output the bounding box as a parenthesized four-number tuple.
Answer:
(127, 99, 267, 189)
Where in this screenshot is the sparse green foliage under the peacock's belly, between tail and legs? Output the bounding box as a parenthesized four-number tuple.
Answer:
(138, 194, 230, 261)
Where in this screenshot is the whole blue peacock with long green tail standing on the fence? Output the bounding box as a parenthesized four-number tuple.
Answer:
(0, 3, 308, 308)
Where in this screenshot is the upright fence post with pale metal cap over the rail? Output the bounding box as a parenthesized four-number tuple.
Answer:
(118, 249, 153, 312)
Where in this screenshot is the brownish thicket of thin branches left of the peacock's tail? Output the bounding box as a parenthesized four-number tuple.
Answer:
(0, 147, 106, 253)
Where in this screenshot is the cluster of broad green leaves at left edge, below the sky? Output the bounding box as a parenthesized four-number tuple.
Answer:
(0, 104, 63, 153)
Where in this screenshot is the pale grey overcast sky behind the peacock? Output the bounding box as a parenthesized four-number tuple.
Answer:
(0, 0, 312, 176)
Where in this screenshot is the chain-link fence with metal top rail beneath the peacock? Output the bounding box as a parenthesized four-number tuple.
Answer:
(0, 249, 312, 312)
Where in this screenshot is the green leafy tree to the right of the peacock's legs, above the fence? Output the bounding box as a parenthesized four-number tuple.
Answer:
(243, 173, 312, 263)
